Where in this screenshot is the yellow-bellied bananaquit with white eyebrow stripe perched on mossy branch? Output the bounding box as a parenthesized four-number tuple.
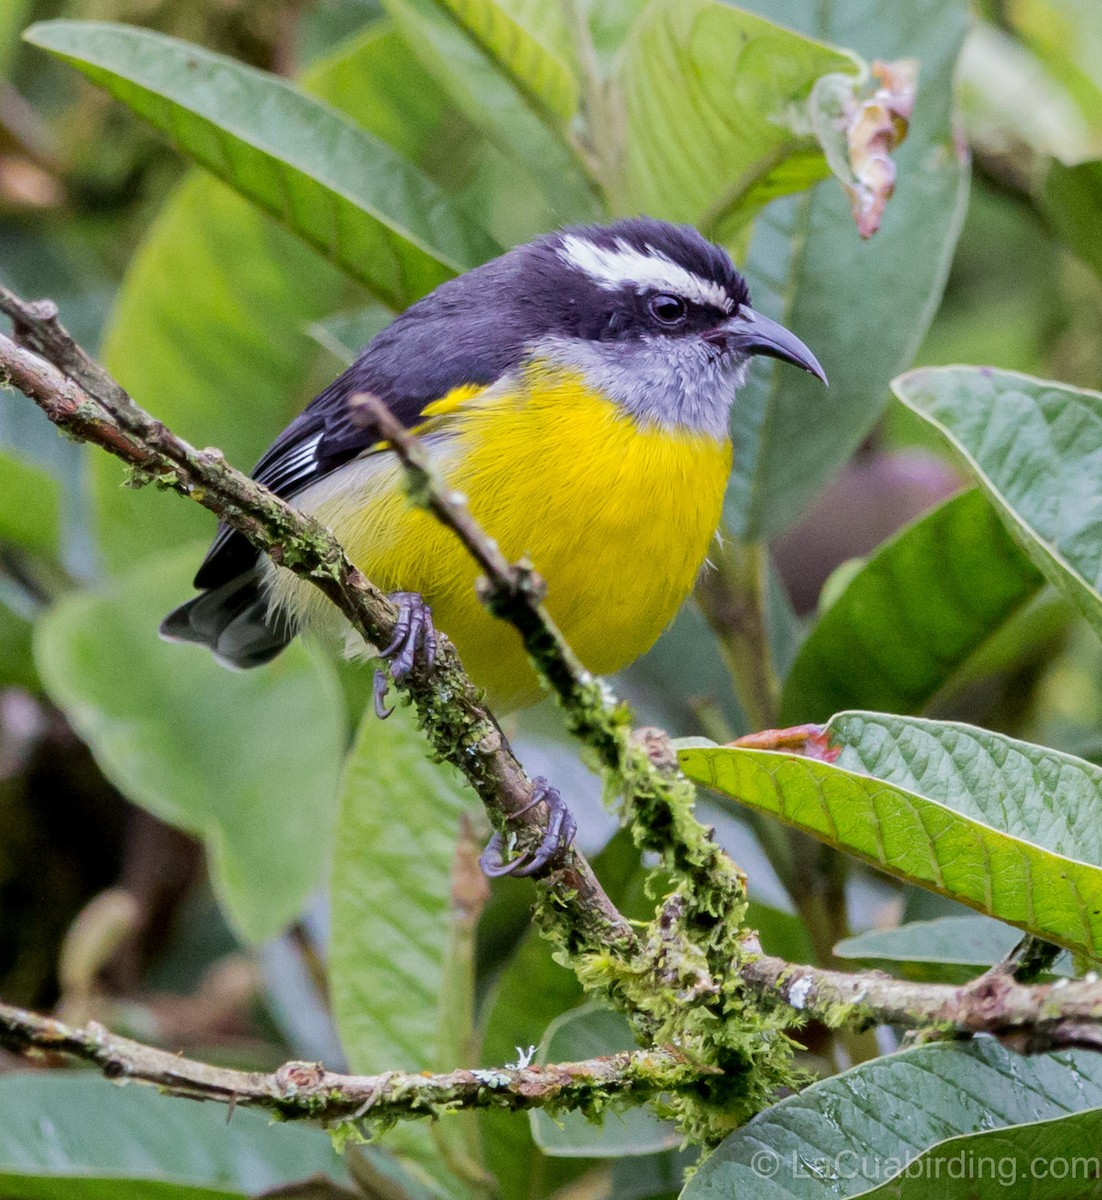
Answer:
(161, 217, 826, 864)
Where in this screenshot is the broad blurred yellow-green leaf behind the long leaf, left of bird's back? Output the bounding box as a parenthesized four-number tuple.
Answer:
(91, 26, 465, 569)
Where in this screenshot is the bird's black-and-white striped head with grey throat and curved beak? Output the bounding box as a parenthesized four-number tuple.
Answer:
(507, 217, 826, 437)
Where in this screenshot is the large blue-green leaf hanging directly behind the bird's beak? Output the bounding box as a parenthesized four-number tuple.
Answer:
(725, 0, 969, 539)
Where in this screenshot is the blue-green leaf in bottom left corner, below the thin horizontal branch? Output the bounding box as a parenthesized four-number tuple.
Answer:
(0, 1072, 347, 1200)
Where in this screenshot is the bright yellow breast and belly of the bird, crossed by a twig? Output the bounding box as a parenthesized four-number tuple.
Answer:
(282, 368, 731, 710)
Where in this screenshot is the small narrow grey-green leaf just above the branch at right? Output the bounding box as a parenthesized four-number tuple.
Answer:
(834, 917, 1022, 983)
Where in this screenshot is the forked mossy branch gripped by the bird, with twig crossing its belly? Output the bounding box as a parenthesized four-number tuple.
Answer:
(0, 289, 791, 1141)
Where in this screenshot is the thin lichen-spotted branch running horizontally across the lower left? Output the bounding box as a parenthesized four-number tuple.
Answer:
(0, 1004, 701, 1123)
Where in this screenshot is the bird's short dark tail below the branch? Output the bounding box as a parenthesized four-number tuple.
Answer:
(161, 568, 294, 670)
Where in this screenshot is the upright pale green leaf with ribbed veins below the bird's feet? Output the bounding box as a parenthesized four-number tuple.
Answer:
(329, 707, 474, 1194)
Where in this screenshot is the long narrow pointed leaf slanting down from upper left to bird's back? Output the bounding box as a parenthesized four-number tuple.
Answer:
(25, 20, 498, 307)
